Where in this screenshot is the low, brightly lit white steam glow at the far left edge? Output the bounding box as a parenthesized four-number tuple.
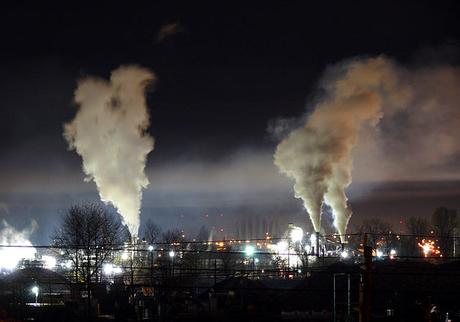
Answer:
(0, 220, 38, 270)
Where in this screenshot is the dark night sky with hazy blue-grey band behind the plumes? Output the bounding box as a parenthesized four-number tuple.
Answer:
(0, 1, 460, 242)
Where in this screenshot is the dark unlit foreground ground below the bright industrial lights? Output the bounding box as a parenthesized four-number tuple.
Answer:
(0, 260, 460, 322)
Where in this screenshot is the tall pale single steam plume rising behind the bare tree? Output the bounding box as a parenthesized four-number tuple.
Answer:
(64, 66, 155, 236)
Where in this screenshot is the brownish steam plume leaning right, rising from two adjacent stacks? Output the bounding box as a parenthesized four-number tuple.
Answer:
(274, 57, 411, 239)
